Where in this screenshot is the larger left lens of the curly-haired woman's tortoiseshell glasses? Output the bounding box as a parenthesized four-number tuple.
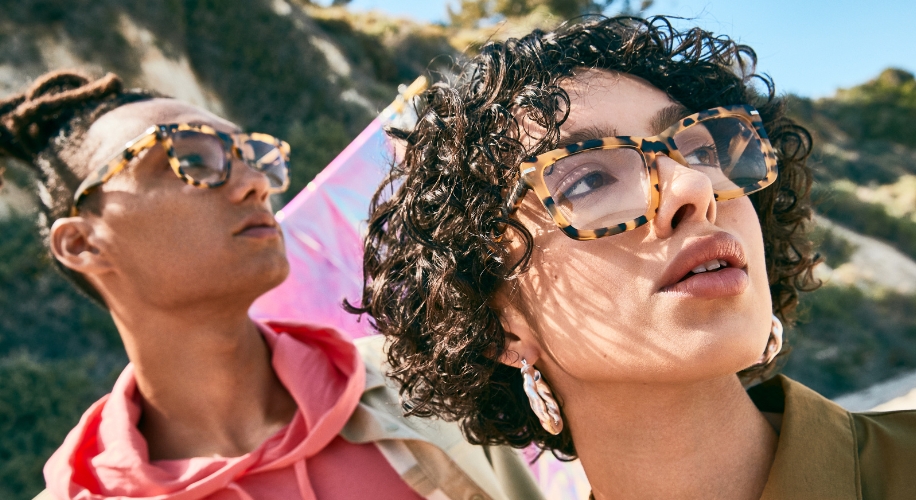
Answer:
(544, 147, 651, 230)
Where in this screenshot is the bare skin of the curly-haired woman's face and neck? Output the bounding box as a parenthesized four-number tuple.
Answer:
(497, 71, 776, 500)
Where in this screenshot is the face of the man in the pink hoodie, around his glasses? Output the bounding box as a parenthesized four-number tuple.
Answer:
(70, 99, 289, 310)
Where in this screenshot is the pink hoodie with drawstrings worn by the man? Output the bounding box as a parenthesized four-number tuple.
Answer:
(44, 323, 421, 500)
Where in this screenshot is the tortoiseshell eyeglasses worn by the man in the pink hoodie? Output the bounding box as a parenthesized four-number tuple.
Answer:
(71, 123, 289, 216)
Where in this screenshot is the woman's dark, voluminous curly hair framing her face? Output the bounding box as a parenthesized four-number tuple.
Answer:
(350, 17, 818, 458)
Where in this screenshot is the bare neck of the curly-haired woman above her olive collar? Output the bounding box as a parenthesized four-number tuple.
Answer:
(564, 376, 777, 500)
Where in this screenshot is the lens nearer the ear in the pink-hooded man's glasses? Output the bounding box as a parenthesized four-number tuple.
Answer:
(171, 130, 227, 183)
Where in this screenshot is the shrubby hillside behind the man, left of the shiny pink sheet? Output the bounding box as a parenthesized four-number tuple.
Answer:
(0, 0, 456, 500)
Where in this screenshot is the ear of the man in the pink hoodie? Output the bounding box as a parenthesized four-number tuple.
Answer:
(50, 217, 111, 275)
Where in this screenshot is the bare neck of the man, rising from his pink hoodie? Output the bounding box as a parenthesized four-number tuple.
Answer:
(112, 296, 296, 460)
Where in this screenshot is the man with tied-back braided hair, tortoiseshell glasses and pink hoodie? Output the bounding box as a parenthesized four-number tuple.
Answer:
(0, 71, 539, 500)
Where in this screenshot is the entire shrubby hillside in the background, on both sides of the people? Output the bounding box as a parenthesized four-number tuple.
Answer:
(0, 0, 916, 499)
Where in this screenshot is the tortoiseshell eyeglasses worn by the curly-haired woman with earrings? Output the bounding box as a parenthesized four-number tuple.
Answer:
(507, 105, 777, 240)
